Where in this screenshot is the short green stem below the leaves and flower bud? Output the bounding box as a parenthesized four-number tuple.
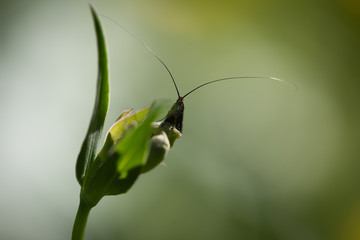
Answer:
(71, 199, 91, 240)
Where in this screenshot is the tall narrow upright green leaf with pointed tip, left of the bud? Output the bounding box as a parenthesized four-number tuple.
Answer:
(76, 6, 109, 185)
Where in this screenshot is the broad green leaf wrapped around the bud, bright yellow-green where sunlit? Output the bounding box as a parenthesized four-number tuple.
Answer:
(81, 105, 167, 207)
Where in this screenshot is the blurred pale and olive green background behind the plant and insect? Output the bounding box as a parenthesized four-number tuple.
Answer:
(0, 0, 360, 240)
